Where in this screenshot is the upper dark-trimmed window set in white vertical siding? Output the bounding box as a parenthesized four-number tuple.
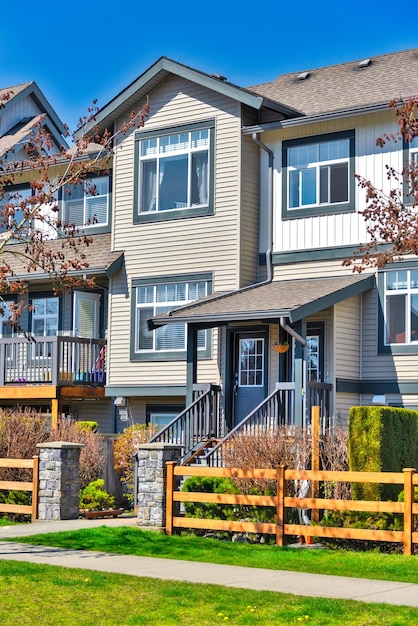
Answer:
(283, 131, 354, 218)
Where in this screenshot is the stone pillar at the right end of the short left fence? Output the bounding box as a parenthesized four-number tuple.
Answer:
(38, 441, 84, 520)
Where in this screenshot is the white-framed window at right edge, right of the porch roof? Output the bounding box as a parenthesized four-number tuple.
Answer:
(384, 269, 418, 345)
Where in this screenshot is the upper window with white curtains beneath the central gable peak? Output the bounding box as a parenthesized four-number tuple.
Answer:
(135, 122, 214, 222)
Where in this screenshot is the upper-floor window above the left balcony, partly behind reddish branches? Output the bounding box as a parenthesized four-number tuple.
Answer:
(63, 176, 110, 229)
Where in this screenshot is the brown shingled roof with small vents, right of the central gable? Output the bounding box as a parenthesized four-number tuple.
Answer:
(250, 48, 418, 126)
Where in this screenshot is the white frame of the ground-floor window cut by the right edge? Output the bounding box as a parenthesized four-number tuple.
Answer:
(384, 269, 418, 346)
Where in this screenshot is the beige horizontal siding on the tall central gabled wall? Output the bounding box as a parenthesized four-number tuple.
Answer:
(109, 77, 241, 385)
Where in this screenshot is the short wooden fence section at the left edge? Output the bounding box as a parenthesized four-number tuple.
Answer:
(0, 456, 39, 522)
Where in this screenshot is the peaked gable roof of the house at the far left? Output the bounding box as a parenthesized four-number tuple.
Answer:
(0, 81, 67, 153)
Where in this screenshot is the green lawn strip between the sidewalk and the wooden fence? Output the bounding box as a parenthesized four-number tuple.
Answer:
(6, 526, 418, 584)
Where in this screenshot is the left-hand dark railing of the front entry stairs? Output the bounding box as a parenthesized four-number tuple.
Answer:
(150, 385, 220, 462)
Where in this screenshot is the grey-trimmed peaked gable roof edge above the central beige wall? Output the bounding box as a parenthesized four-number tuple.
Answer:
(75, 57, 299, 137)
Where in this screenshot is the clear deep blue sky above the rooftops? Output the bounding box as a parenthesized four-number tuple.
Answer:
(0, 0, 418, 136)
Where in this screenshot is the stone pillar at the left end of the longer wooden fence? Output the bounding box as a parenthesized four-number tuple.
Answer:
(135, 443, 182, 529)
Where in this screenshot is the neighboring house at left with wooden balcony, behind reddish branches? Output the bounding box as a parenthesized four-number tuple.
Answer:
(0, 82, 117, 424)
